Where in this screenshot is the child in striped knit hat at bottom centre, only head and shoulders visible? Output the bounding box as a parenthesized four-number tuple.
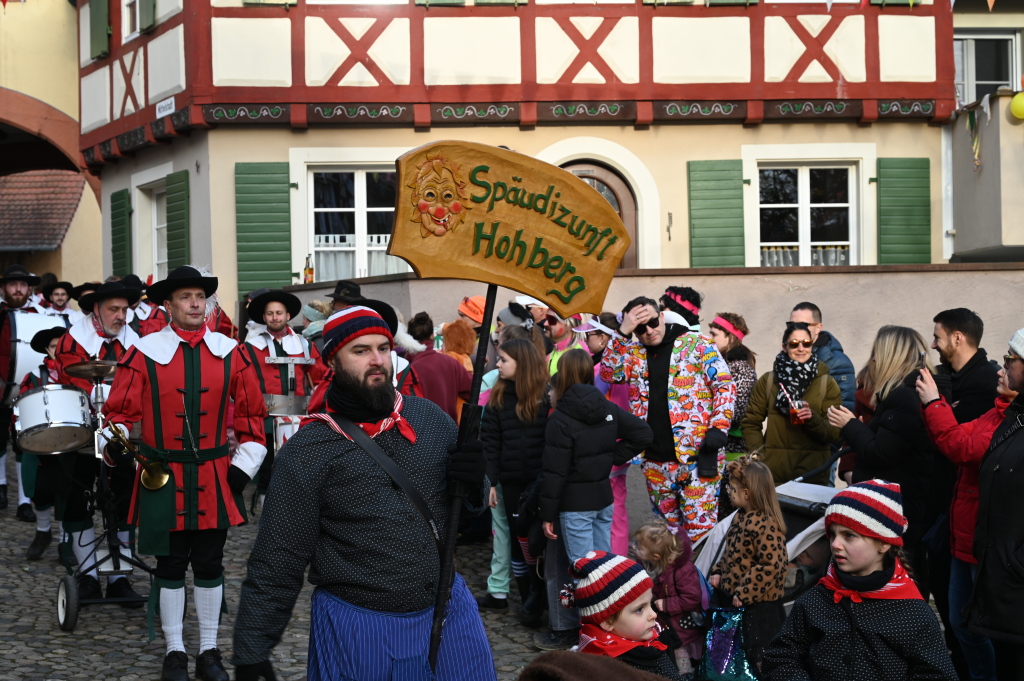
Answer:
(561, 551, 684, 681)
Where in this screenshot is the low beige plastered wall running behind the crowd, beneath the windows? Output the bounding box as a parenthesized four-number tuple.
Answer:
(286, 265, 1024, 382)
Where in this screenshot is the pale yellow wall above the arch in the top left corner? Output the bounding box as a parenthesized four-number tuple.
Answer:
(0, 0, 78, 121)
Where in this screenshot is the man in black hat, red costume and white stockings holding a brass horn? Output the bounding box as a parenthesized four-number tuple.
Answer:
(103, 266, 266, 681)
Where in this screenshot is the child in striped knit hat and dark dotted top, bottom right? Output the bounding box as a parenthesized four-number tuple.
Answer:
(763, 480, 956, 681)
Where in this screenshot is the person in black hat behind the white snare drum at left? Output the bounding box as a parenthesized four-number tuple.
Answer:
(18, 327, 68, 560)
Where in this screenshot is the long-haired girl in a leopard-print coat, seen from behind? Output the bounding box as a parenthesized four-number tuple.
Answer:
(708, 455, 790, 669)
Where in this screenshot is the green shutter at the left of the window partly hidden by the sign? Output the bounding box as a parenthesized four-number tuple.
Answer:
(234, 163, 292, 295)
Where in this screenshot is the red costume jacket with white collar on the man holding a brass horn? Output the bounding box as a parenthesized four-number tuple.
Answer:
(103, 327, 266, 555)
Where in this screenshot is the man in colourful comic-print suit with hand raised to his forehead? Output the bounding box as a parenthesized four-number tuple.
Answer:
(601, 288, 736, 541)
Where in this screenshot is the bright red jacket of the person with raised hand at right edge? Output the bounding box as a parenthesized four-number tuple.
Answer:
(924, 395, 1013, 564)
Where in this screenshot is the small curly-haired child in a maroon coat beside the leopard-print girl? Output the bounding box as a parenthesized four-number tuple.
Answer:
(634, 520, 708, 674)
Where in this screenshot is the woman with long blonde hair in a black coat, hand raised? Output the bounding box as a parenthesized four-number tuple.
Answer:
(828, 326, 948, 598)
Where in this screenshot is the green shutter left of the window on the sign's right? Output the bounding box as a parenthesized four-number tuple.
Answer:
(686, 160, 746, 267)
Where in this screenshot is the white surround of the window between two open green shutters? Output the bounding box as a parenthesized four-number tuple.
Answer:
(739, 143, 879, 267)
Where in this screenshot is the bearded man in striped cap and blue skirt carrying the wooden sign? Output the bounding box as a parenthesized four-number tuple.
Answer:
(233, 305, 497, 681)
